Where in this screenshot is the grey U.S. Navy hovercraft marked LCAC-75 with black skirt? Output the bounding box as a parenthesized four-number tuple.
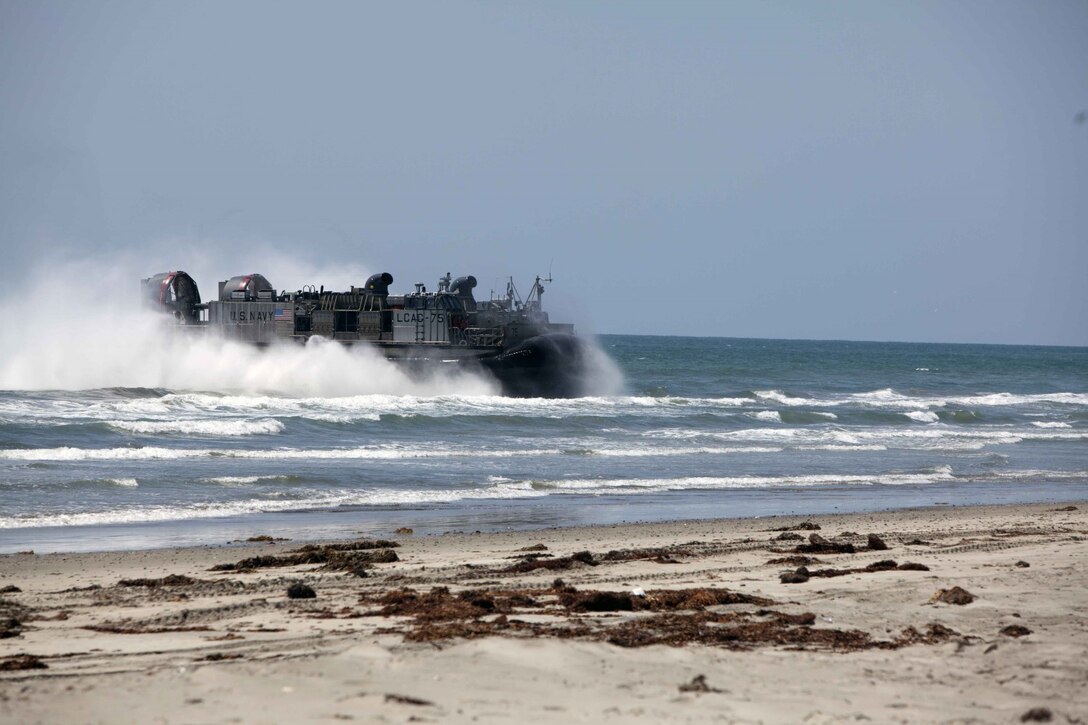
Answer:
(141, 271, 586, 397)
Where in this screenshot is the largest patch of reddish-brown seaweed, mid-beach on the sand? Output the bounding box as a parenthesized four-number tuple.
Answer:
(345, 579, 959, 651)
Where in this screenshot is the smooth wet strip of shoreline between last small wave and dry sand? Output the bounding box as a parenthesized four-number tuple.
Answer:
(0, 480, 1088, 555)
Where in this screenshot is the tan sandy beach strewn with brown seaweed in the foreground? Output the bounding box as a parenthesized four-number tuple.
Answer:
(0, 504, 1088, 723)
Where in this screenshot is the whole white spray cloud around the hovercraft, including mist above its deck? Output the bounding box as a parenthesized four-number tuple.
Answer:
(0, 250, 496, 396)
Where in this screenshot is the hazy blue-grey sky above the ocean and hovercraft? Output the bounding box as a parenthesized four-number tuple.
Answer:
(0, 0, 1088, 345)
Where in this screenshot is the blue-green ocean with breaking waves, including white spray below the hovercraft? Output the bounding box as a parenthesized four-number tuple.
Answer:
(0, 335, 1088, 552)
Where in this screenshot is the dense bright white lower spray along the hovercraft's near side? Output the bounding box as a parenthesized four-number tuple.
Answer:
(0, 307, 496, 397)
